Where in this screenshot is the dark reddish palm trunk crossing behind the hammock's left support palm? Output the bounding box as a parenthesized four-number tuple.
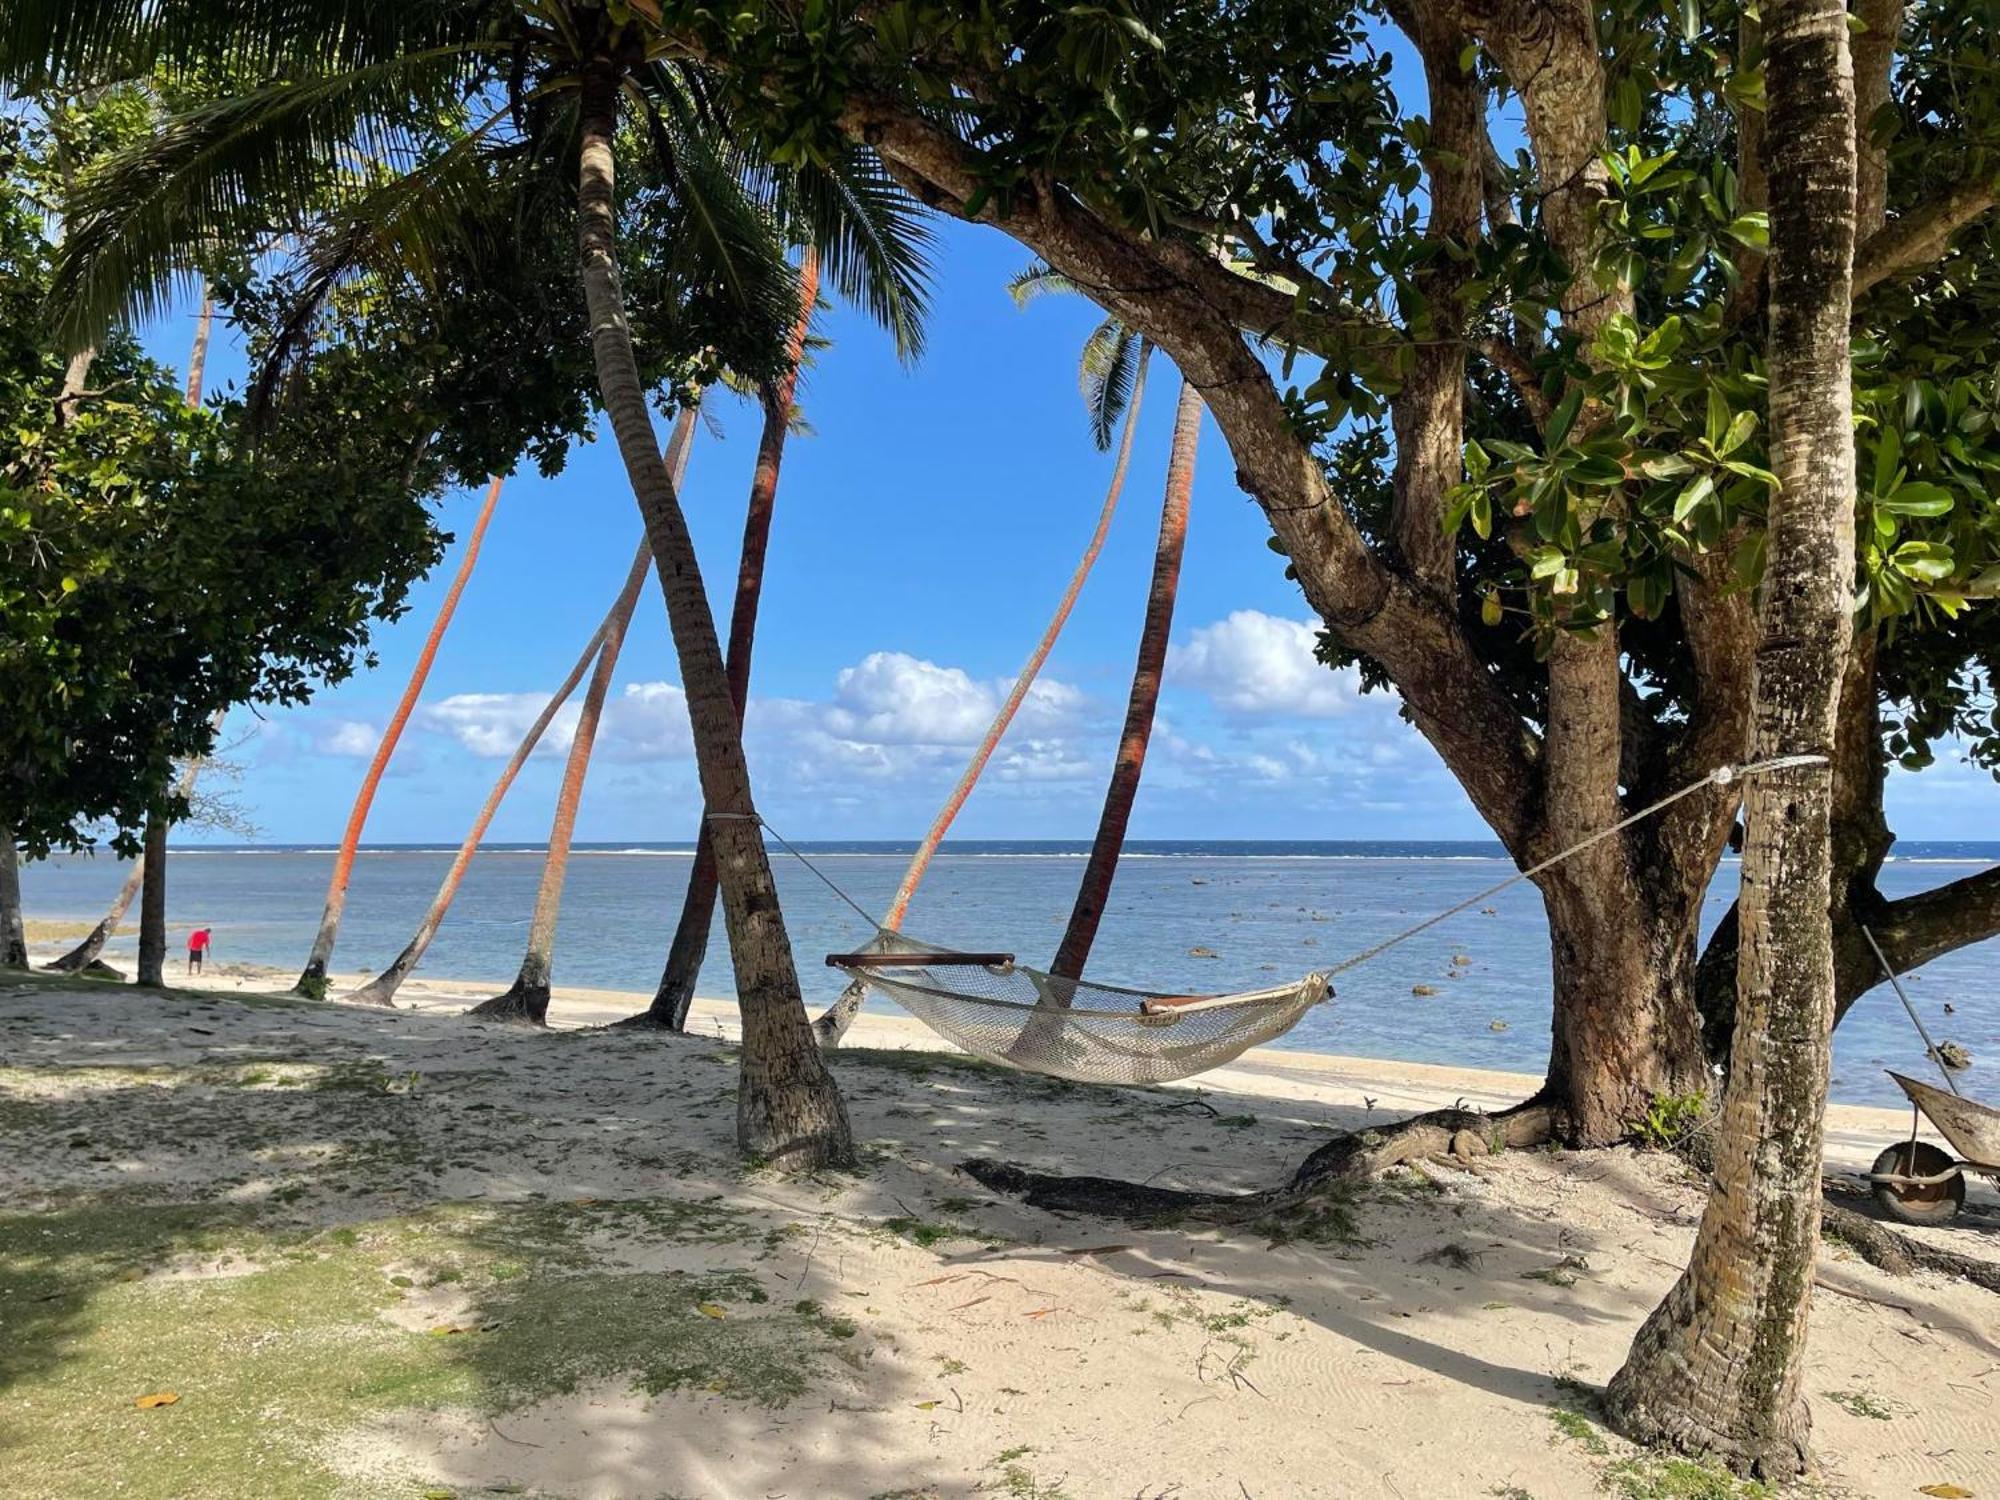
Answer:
(632, 256, 820, 1032)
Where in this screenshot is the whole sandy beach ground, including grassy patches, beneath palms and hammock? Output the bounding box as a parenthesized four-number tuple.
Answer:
(0, 972, 2000, 1500)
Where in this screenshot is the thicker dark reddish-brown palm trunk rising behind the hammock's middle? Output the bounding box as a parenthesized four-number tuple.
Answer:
(1050, 380, 1202, 988)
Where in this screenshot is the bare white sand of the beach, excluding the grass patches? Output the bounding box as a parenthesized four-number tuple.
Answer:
(0, 976, 2000, 1500)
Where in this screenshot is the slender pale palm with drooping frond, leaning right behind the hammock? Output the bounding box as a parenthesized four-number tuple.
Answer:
(816, 288, 1152, 1046)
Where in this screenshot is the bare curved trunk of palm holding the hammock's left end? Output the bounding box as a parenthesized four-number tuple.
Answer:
(576, 58, 854, 1170)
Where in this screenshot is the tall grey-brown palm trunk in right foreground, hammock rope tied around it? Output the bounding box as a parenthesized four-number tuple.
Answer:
(1606, 0, 1856, 1480)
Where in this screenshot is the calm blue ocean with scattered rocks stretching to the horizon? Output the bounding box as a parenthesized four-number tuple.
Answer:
(22, 842, 2000, 1104)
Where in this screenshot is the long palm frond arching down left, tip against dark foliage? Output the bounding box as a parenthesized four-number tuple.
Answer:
(50, 48, 480, 346)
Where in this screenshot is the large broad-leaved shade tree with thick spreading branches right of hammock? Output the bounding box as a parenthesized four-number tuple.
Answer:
(628, 0, 1996, 1142)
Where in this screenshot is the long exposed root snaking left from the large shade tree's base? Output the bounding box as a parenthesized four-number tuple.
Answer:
(958, 1100, 1554, 1224)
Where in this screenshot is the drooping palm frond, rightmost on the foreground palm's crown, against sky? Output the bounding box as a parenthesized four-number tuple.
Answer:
(782, 146, 936, 360)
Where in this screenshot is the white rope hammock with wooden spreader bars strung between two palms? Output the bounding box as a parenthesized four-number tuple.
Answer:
(826, 930, 1332, 1084)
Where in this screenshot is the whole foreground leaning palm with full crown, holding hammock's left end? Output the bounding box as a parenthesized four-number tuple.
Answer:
(0, 0, 920, 1168)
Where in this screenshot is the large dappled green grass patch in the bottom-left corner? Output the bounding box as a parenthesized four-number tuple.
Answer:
(0, 1198, 858, 1500)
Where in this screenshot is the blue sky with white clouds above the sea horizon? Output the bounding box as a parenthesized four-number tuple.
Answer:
(164, 210, 2000, 842)
